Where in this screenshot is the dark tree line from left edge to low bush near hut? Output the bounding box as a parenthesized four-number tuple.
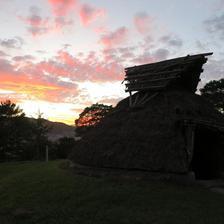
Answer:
(0, 100, 74, 162)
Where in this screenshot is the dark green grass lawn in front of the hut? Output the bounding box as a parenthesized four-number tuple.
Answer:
(0, 161, 224, 224)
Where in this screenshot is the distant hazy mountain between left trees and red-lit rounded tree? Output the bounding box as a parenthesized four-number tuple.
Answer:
(27, 118, 75, 141)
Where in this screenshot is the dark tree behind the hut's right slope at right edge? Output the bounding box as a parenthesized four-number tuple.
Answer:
(200, 79, 224, 113)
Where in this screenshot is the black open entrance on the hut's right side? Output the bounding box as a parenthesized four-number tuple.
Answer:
(192, 127, 220, 180)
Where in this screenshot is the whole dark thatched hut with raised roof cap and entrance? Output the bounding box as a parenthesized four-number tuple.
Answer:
(71, 54, 224, 179)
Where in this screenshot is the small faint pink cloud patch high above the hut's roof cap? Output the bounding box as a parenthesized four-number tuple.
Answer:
(134, 12, 153, 34)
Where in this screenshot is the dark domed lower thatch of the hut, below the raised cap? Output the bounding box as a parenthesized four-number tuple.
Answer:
(71, 90, 224, 173)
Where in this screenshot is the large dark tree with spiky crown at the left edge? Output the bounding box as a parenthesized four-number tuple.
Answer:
(0, 100, 32, 161)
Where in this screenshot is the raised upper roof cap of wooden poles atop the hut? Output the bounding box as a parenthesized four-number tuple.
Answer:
(124, 53, 212, 92)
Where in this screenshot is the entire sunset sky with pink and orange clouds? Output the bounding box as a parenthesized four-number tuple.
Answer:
(0, 0, 224, 125)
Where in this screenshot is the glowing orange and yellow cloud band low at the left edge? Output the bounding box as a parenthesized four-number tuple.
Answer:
(0, 57, 77, 102)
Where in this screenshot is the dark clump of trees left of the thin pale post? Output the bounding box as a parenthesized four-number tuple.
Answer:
(0, 100, 47, 161)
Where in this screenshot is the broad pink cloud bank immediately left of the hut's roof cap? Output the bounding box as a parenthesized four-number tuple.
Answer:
(53, 50, 123, 82)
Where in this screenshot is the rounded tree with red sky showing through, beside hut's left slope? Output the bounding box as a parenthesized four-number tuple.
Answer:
(75, 103, 113, 135)
